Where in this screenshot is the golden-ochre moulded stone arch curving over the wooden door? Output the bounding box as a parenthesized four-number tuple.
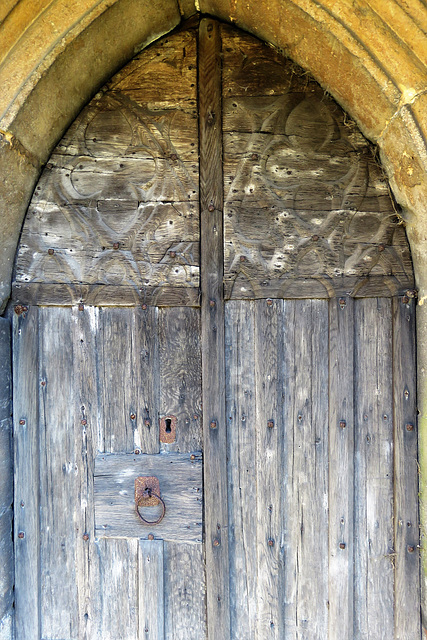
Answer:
(0, 0, 427, 632)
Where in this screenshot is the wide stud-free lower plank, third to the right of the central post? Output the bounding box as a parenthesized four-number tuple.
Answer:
(285, 301, 328, 639)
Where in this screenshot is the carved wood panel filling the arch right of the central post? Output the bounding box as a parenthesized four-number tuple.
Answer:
(223, 27, 413, 298)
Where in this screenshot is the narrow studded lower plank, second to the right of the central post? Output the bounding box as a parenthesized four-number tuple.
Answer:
(254, 300, 284, 640)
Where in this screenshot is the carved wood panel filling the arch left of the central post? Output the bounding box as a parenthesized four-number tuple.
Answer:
(15, 30, 199, 304)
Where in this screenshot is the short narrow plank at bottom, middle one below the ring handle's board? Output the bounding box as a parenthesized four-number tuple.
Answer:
(138, 540, 165, 640)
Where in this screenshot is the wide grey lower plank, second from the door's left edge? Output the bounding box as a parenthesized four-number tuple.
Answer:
(39, 307, 80, 638)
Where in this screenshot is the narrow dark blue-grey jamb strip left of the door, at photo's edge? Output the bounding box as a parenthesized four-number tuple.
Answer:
(0, 318, 14, 621)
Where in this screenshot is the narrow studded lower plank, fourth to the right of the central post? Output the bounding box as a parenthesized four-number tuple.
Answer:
(329, 298, 354, 640)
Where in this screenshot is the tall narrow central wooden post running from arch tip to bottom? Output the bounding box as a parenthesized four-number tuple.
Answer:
(198, 18, 230, 640)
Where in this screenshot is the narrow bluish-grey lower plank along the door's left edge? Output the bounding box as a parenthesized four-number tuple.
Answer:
(13, 307, 40, 640)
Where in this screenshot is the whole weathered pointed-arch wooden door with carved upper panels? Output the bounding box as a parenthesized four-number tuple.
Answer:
(14, 19, 420, 640)
